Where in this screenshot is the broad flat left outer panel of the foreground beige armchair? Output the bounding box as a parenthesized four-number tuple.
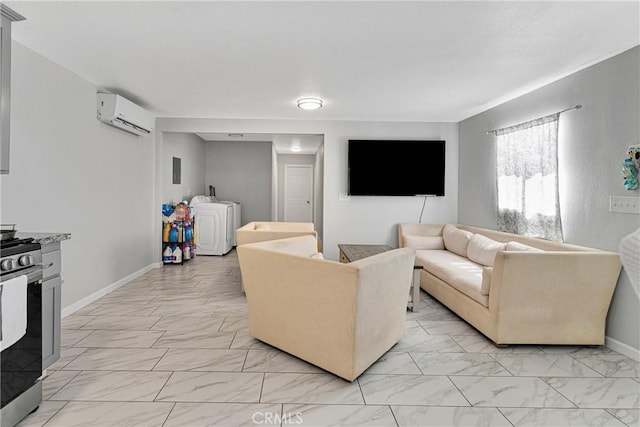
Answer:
(238, 249, 357, 378)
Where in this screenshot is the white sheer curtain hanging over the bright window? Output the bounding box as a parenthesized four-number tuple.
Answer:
(495, 114, 562, 241)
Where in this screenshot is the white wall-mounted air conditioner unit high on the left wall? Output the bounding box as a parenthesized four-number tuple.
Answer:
(98, 93, 154, 135)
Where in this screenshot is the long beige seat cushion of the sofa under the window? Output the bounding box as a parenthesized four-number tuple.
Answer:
(415, 250, 489, 307)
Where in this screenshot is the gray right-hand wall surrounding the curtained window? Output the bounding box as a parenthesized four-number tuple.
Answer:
(458, 47, 640, 352)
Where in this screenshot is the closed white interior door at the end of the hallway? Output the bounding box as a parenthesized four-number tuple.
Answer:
(284, 165, 313, 222)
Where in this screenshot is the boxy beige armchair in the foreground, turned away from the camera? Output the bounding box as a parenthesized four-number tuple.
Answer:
(237, 236, 414, 381)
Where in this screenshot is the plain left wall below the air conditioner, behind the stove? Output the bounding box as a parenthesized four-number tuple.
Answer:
(0, 42, 160, 308)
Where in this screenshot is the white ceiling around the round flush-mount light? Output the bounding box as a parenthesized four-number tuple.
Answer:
(5, 1, 640, 122)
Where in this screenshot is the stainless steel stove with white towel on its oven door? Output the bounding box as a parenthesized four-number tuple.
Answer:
(0, 231, 43, 427)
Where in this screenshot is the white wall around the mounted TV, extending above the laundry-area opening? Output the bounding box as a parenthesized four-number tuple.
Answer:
(156, 118, 458, 260)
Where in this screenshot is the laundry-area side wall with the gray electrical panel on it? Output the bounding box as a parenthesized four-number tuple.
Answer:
(162, 132, 209, 203)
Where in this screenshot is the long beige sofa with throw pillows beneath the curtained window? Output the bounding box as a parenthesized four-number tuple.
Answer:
(398, 224, 621, 345)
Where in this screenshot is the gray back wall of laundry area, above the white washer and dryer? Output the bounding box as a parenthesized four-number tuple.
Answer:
(204, 141, 271, 225)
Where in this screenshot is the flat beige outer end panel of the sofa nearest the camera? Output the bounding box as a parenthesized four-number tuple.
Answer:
(489, 251, 621, 343)
